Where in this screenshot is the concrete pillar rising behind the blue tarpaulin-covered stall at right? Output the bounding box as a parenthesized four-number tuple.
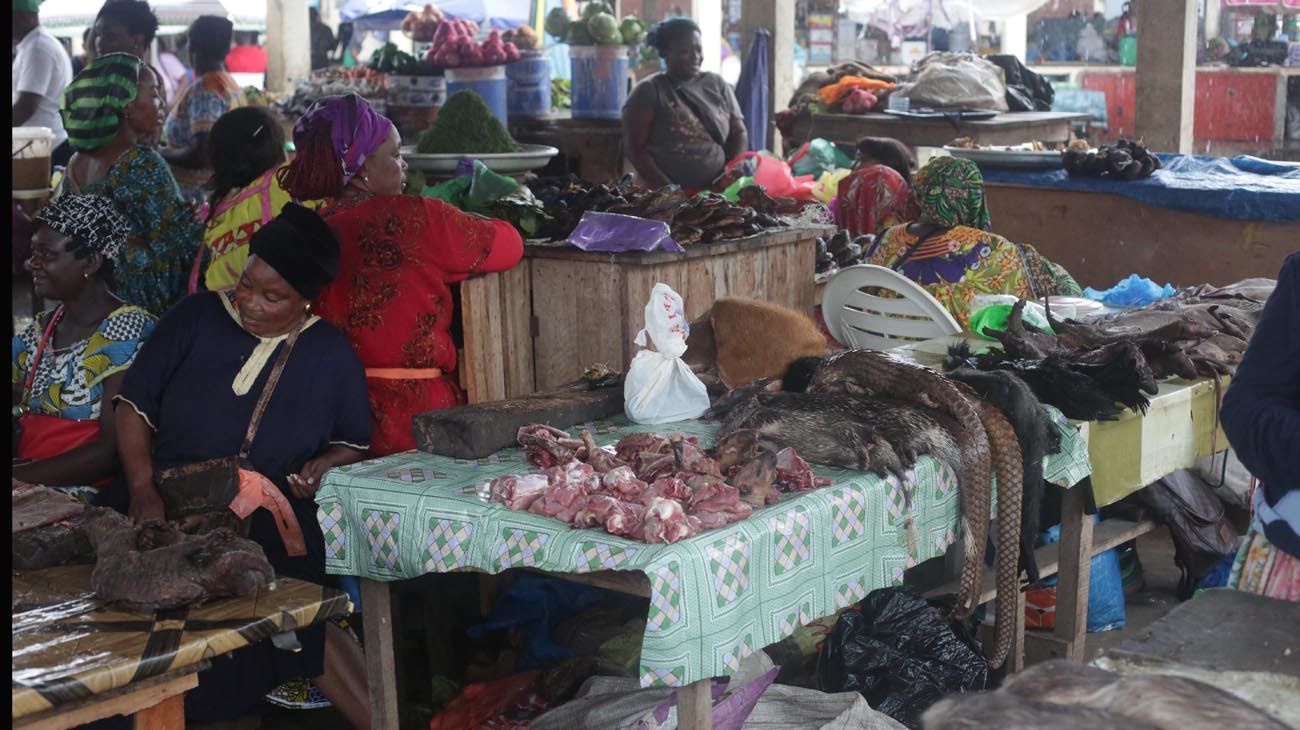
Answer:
(1134, 0, 1196, 155)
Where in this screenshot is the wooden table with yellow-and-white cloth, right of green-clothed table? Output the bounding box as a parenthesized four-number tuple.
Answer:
(900, 335, 1229, 669)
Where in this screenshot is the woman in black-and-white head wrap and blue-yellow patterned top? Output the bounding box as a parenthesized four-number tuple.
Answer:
(12, 195, 155, 508)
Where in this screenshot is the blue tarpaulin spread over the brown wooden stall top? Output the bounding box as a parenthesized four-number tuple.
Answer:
(980, 153, 1300, 223)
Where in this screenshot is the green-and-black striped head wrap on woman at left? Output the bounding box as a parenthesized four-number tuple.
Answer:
(61, 53, 144, 151)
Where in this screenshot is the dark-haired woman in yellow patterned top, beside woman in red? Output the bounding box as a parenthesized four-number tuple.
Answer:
(197, 107, 304, 291)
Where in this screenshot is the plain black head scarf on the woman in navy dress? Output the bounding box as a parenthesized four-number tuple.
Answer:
(248, 203, 338, 299)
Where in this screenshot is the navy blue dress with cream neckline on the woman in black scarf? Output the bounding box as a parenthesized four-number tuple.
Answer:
(117, 292, 371, 721)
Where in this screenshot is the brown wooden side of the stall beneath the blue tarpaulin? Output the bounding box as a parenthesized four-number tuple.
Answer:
(984, 182, 1300, 288)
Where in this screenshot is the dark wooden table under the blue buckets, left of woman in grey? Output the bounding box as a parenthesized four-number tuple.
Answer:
(510, 112, 632, 183)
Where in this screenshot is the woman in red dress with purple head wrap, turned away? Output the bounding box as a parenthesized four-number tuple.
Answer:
(281, 94, 524, 456)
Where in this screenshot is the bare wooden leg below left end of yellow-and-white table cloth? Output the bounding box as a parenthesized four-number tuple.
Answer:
(1026, 487, 1092, 661)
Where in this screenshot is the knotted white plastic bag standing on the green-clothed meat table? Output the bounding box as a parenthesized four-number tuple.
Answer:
(623, 283, 709, 423)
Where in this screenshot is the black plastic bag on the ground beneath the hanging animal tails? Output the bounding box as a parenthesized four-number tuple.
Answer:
(816, 588, 988, 729)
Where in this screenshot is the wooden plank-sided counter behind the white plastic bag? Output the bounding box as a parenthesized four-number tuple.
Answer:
(460, 226, 832, 403)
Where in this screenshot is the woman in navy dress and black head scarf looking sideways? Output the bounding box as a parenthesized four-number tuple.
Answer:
(116, 205, 371, 727)
